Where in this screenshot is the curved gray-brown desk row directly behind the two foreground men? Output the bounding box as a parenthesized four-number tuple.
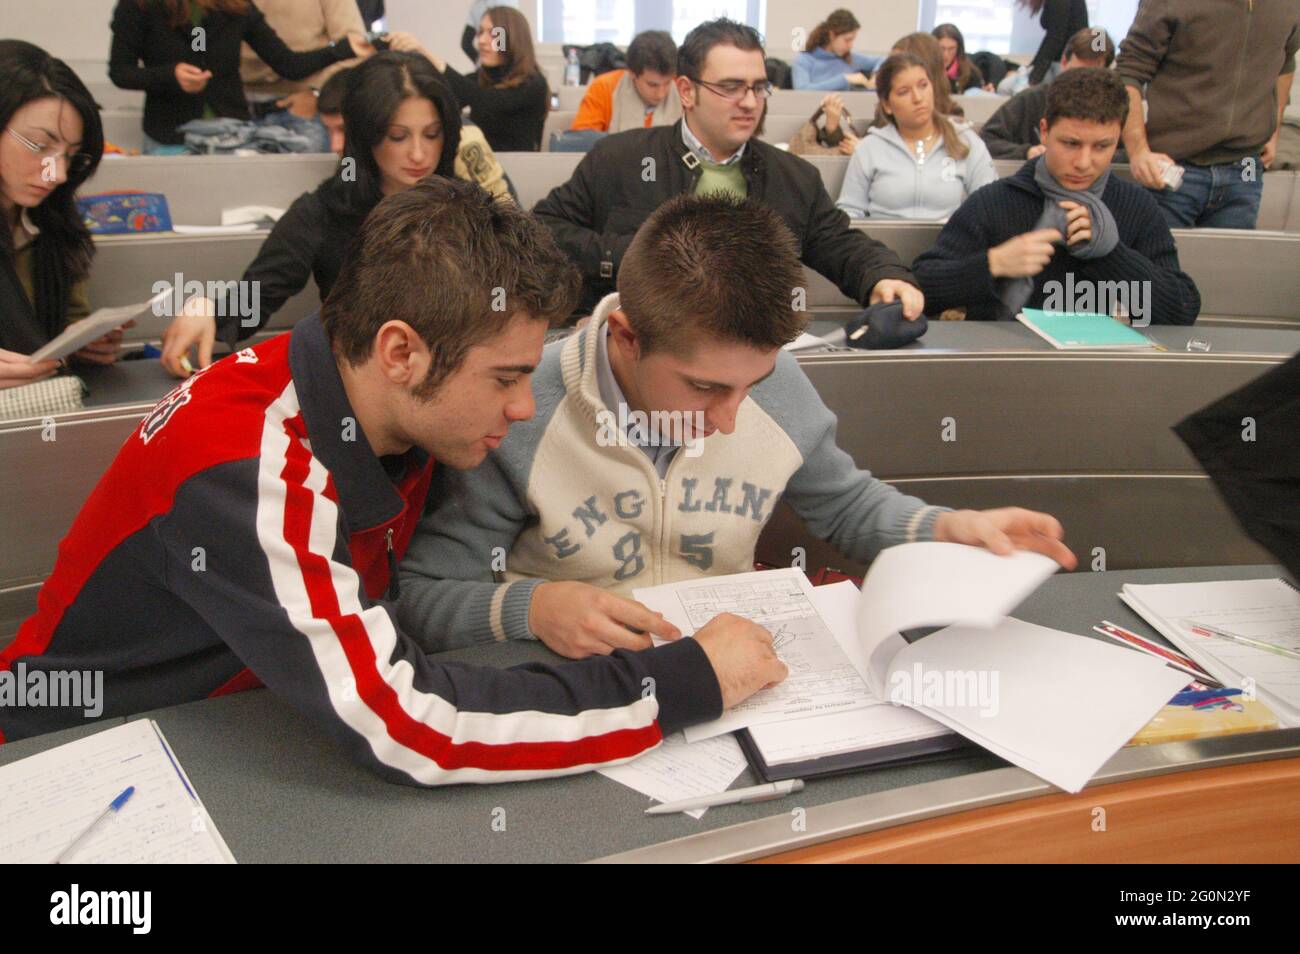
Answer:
(0, 321, 1300, 641)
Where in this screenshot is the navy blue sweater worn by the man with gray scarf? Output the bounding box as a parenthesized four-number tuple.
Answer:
(913, 160, 1201, 325)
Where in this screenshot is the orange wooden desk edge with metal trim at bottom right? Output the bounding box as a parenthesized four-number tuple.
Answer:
(595, 729, 1300, 863)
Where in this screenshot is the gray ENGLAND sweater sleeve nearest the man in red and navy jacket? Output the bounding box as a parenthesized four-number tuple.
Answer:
(398, 444, 545, 652)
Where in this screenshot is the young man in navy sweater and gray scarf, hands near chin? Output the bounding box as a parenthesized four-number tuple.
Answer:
(913, 68, 1201, 325)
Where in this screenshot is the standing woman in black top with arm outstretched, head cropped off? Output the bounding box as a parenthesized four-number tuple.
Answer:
(108, 0, 374, 151)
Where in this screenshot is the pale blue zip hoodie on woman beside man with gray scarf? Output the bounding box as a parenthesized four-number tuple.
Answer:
(836, 123, 997, 220)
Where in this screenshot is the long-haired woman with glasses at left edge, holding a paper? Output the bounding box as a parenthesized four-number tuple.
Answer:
(0, 40, 122, 387)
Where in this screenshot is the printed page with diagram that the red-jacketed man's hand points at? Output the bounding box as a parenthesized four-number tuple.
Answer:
(633, 568, 879, 742)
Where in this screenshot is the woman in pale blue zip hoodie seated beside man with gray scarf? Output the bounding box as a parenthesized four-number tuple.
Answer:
(836, 53, 997, 220)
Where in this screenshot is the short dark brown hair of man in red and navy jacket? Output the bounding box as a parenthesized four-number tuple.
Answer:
(321, 175, 581, 396)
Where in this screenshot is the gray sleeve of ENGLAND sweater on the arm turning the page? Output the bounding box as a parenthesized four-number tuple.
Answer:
(751, 351, 949, 560)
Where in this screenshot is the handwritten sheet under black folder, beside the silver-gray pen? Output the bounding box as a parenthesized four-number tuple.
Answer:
(597, 732, 746, 819)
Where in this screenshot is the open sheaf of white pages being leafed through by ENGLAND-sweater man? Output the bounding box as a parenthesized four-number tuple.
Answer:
(636, 543, 1187, 792)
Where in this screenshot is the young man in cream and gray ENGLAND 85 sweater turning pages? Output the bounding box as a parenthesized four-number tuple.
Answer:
(398, 194, 1075, 658)
